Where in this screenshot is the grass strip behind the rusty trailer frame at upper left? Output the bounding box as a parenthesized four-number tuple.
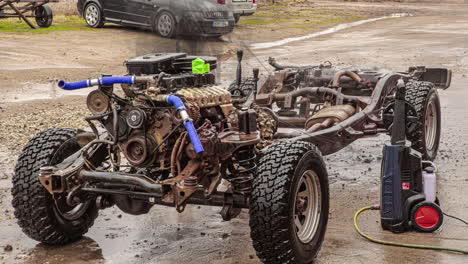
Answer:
(0, 15, 93, 33)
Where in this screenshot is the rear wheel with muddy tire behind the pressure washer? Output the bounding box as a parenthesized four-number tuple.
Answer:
(406, 81, 441, 160)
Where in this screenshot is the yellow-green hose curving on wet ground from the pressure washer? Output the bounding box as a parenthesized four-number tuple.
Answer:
(354, 205, 468, 254)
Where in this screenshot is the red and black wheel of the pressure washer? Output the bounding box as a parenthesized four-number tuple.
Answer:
(411, 202, 444, 233)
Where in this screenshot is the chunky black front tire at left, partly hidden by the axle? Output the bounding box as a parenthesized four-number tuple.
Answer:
(12, 128, 98, 245)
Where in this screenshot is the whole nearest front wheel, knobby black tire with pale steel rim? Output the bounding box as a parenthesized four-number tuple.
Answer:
(250, 141, 329, 263)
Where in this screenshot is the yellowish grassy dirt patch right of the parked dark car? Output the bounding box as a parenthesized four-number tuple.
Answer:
(228, 1, 421, 42)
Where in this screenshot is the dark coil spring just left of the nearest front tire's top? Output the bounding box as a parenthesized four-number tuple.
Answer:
(228, 146, 257, 193)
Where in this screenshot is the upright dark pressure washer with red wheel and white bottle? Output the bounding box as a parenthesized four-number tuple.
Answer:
(380, 80, 443, 232)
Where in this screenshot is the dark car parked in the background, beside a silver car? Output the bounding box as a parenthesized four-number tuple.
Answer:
(78, 0, 235, 38)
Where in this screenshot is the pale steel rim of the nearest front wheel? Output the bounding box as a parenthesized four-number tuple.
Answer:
(293, 170, 322, 244)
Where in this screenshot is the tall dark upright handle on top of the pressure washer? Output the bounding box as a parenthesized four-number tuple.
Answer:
(391, 79, 406, 146)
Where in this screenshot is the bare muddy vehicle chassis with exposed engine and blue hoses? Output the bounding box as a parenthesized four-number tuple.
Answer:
(13, 53, 451, 263)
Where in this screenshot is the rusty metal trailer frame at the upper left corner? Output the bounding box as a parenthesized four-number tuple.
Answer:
(0, 0, 59, 29)
